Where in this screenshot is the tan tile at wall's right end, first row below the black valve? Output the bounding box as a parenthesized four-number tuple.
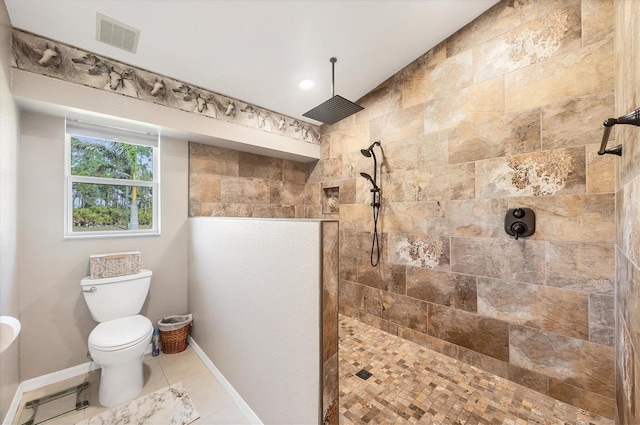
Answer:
(545, 242, 615, 294)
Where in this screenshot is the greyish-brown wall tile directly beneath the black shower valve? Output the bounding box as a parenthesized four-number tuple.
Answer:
(451, 237, 545, 283)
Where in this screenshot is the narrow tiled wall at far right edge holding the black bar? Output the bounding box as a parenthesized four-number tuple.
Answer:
(610, 0, 640, 424)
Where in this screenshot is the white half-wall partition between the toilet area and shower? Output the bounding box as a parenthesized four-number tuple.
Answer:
(189, 217, 322, 424)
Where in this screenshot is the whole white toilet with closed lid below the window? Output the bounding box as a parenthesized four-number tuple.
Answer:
(80, 270, 153, 407)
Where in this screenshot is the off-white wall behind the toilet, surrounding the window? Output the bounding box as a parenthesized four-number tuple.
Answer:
(19, 112, 188, 380)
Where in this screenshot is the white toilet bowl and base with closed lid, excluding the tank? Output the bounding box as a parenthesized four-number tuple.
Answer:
(89, 315, 153, 407)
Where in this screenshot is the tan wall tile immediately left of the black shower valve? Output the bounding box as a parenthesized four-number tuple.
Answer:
(425, 199, 507, 238)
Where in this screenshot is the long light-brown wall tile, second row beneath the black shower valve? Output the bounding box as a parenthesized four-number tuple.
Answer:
(478, 278, 589, 340)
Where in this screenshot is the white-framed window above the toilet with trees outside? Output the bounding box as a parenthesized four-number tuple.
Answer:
(65, 121, 160, 237)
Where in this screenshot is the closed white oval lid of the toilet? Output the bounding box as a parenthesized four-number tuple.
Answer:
(89, 314, 153, 351)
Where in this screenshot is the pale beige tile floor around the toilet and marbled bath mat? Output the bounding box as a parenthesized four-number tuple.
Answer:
(14, 347, 250, 425)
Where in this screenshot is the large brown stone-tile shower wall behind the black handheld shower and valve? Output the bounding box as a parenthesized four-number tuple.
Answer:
(304, 0, 616, 417)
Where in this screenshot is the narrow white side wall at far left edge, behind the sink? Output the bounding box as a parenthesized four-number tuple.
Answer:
(0, 0, 20, 420)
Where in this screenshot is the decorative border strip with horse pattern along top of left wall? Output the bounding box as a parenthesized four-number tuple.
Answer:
(12, 29, 320, 144)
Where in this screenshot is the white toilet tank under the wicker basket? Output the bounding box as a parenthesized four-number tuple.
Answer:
(80, 270, 152, 322)
